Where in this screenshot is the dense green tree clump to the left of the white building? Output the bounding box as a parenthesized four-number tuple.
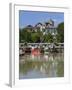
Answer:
(19, 28, 43, 43)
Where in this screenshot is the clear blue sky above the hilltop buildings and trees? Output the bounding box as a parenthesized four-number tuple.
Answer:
(19, 10, 64, 28)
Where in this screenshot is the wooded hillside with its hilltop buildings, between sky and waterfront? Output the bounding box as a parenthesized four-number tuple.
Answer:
(19, 19, 64, 43)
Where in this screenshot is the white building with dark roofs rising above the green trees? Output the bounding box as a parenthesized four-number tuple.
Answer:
(35, 19, 57, 35)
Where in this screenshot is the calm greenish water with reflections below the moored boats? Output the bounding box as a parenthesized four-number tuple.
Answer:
(19, 53, 64, 79)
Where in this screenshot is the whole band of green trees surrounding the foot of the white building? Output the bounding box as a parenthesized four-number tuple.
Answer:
(19, 22, 64, 43)
